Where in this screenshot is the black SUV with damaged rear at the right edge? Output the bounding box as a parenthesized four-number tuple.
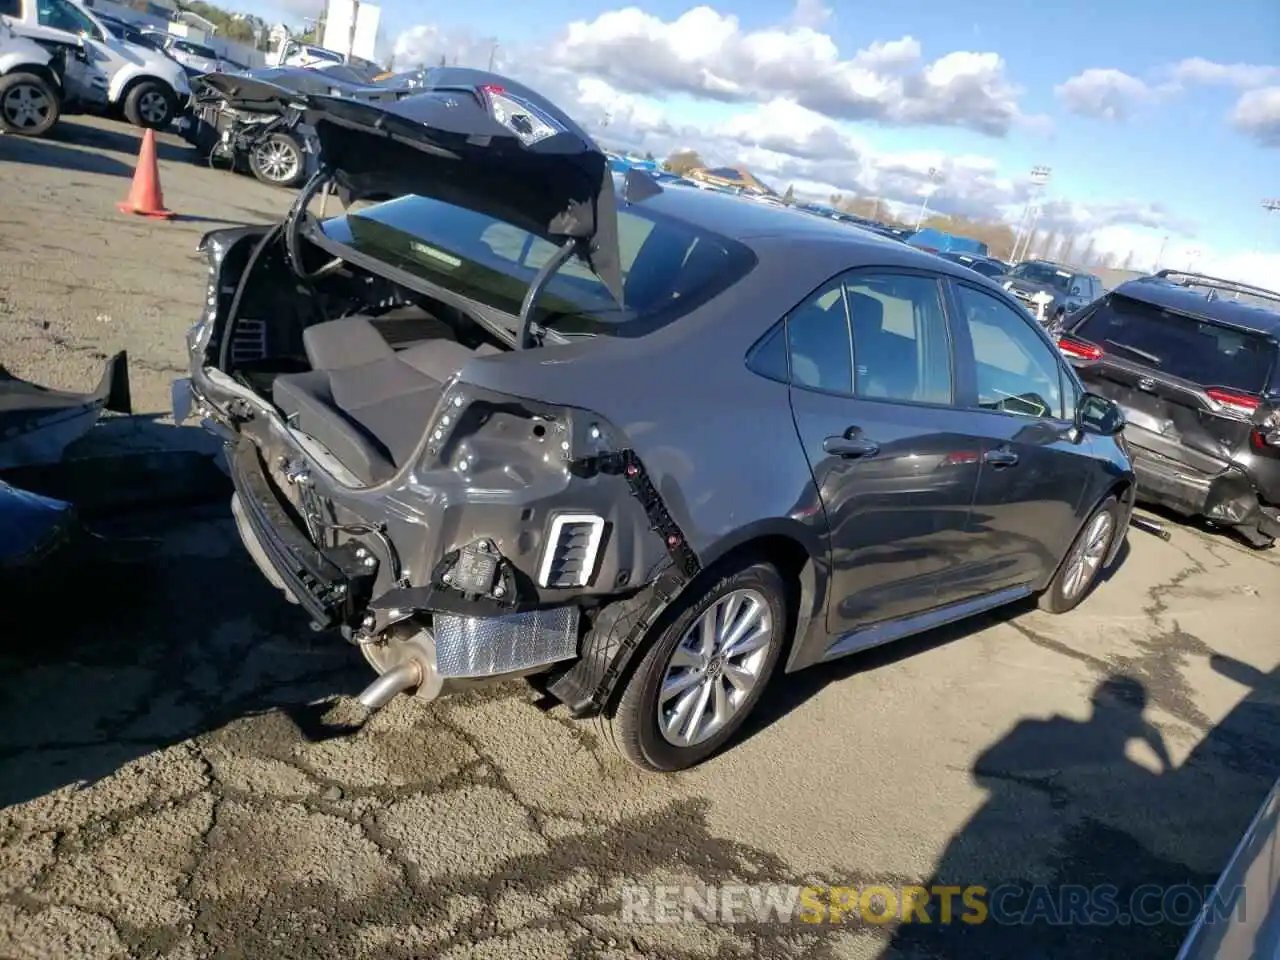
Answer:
(1059, 270, 1280, 548)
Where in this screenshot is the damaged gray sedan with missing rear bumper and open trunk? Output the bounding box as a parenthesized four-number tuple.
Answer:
(175, 69, 1133, 771)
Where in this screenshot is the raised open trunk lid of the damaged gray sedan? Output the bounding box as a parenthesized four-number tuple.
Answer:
(306, 68, 622, 303)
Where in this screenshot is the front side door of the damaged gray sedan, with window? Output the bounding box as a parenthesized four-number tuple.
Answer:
(943, 282, 1094, 599)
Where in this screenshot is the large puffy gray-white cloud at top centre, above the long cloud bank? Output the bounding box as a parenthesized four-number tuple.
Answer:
(547, 4, 1021, 136)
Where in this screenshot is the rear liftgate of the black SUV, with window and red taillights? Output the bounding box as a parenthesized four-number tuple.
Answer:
(1060, 293, 1280, 476)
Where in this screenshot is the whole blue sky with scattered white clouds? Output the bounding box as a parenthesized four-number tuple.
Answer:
(244, 0, 1280, 287)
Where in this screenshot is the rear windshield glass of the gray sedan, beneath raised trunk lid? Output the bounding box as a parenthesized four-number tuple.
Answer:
(324, 195, 755, 337)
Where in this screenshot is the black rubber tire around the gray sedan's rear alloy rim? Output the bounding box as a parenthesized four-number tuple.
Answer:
(596, 562, 790, 773)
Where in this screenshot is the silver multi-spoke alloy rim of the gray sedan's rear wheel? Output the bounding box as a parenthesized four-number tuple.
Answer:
(658, 589, 777, 748)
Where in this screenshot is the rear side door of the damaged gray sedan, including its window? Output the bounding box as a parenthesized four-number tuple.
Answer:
(787, 271, 980, 636)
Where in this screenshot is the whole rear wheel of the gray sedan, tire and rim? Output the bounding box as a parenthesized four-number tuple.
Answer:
(599, 562, 787, 772)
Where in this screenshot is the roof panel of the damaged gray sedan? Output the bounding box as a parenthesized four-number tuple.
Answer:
(632, 178, 998, 289)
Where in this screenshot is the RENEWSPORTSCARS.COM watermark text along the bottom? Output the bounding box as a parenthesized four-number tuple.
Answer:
(621, 883, 1245, 927)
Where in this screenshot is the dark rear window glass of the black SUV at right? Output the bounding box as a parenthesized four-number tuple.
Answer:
(1074, 296, 1276, 393)
